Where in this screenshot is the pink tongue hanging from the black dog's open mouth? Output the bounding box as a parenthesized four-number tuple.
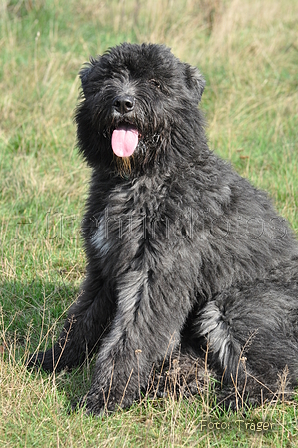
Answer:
(112, 126, 139, 157)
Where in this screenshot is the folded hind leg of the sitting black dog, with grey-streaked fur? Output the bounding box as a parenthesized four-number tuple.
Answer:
(196, 281, 298, 407)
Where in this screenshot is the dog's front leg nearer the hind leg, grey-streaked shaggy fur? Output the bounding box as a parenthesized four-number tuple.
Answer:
(84, 271, 191, 414)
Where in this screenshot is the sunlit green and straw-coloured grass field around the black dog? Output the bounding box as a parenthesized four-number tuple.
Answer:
(0, 0, 298, 447)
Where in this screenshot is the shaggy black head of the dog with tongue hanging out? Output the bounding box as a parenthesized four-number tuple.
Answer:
(76, 43, 205, 175)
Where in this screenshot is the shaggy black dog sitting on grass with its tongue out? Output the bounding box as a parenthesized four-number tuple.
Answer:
(31, 44, 298, 414)
